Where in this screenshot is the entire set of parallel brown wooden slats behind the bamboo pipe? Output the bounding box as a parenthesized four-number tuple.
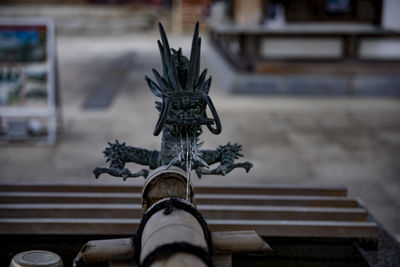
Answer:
(0, 184, 378, 238)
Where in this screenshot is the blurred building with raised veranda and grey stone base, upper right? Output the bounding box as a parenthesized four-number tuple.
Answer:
(211, 0, 400, 95)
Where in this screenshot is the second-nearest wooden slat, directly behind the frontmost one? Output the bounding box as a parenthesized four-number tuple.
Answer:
(0, 204, 367, 221)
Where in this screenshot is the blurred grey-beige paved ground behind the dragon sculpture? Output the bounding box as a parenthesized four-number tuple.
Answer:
(0, 35, 400, 241)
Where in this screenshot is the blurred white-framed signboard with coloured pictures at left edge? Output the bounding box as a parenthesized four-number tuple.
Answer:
(0, 18, 56, 143)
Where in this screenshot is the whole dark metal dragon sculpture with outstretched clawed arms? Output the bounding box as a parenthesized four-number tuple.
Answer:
(93, 23, 253, 180)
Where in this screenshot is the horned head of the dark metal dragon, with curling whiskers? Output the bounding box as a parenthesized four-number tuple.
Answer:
(146, 23, 221, 135)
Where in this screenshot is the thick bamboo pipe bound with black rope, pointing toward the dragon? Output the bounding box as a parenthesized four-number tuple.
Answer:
(138, 166, 212, 267)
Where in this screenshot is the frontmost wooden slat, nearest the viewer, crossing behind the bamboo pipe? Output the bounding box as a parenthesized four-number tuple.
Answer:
(0, 218, 378, 239)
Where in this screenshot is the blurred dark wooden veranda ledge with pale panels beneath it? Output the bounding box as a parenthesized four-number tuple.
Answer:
(210, 23, 400, 73)
